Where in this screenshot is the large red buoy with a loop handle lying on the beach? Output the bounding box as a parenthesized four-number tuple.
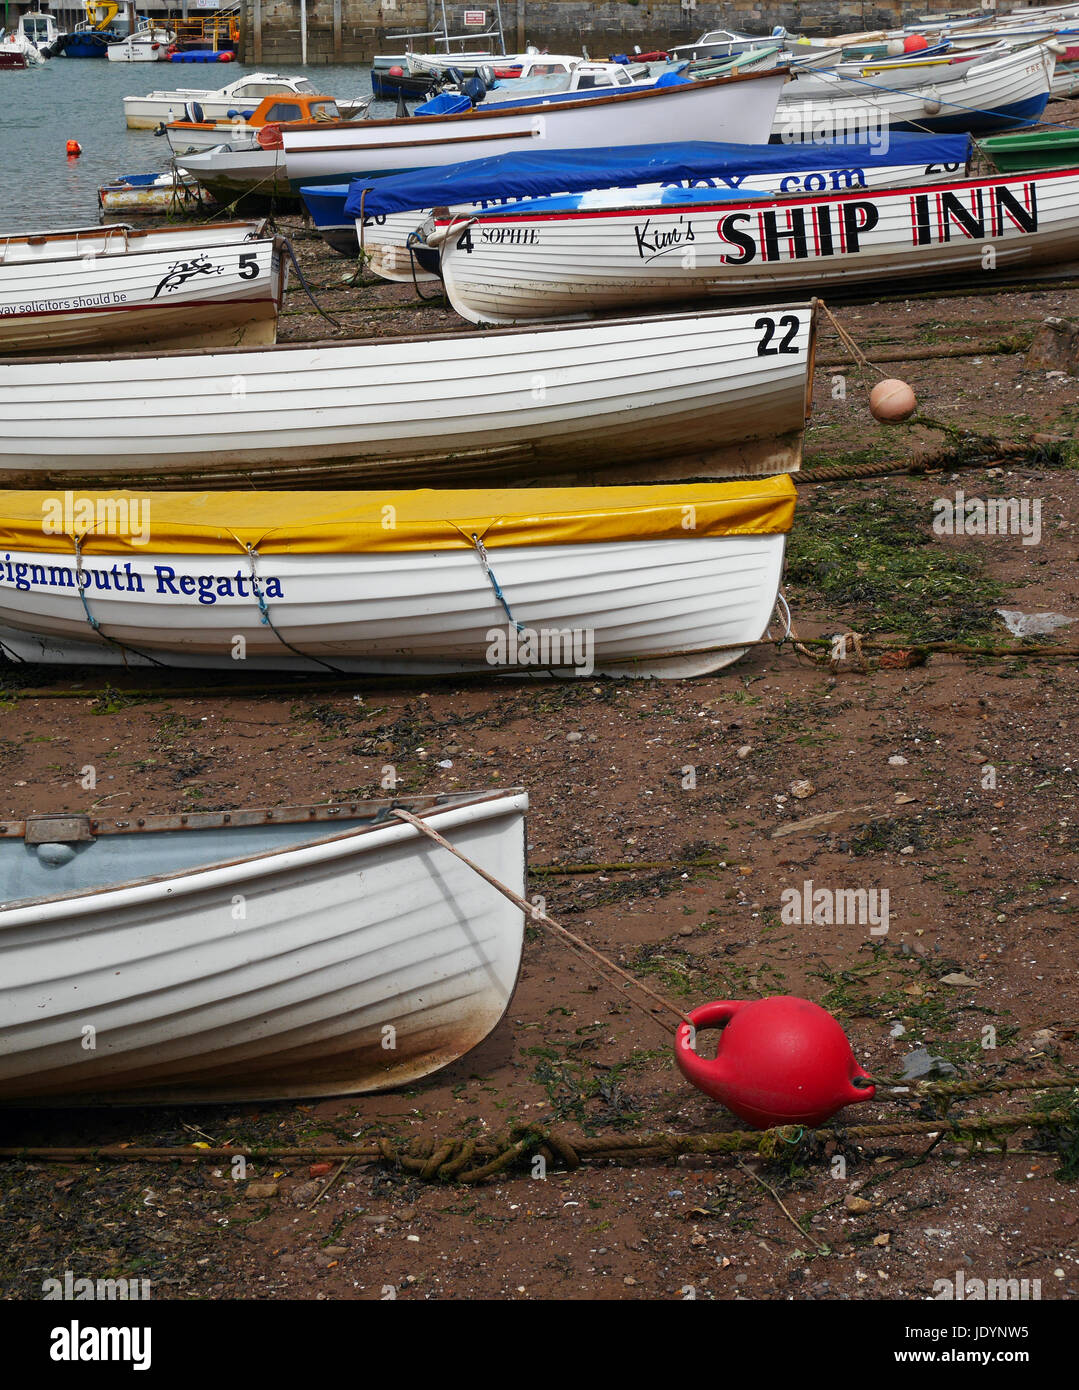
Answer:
(674, 994, 876, 1129)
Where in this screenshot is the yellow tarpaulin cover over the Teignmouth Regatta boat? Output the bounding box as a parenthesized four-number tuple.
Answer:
(0, 474, 795, 556)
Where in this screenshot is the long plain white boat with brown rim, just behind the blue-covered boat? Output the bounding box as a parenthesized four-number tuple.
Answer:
(284, 68, 788, 189)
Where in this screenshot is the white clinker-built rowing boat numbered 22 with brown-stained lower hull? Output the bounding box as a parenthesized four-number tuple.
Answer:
(0, 303, 815, 488)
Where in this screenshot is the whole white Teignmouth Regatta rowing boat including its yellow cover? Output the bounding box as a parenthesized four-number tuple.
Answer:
(0, 474, 794, 677)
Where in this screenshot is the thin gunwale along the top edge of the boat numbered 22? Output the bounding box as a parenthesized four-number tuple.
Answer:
(0, 300, 817, 369)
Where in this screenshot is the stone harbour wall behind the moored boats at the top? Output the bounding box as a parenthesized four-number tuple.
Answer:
(241, 0, 1012, 68)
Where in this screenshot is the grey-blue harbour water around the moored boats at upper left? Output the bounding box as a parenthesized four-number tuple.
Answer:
(0, 57, 394, 236)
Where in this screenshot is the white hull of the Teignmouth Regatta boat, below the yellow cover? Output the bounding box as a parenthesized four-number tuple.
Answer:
(0, 534, 786, 677)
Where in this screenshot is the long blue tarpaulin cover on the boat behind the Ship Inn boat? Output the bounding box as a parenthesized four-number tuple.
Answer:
(345, 133, 973, 217)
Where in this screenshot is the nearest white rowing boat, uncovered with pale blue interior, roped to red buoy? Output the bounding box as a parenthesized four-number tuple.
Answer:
(0, 791, 528, 1105)
